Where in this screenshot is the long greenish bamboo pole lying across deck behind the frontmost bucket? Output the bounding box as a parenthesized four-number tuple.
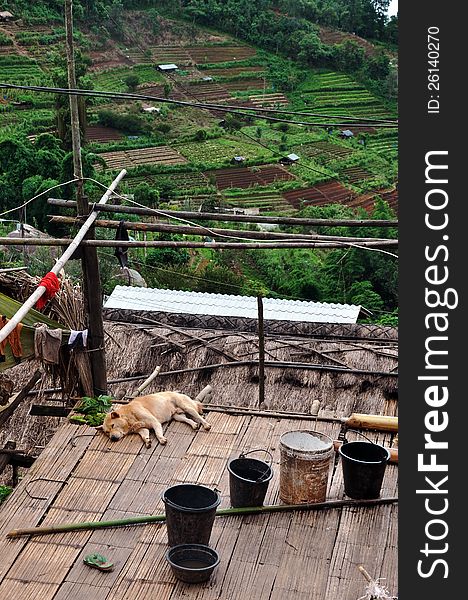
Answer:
(6, 497, 398, 538)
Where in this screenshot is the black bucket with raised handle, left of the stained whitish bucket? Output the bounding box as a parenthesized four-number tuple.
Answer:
(227, 450, 273, 508)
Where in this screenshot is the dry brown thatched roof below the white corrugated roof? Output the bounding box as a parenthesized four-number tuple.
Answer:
(106, 323, 397, 415)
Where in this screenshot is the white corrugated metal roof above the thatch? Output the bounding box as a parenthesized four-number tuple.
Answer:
(104, 285, 361, 323)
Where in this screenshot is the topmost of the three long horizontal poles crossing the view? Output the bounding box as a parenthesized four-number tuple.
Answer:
(47, 198, 398, 227)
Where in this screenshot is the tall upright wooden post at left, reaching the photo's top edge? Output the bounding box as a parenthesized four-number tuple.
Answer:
(65, 0, 107, 395)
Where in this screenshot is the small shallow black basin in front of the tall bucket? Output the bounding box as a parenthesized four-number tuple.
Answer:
(166, 544, 219, 583)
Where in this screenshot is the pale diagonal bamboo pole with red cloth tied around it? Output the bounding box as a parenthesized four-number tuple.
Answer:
(0, 169, 127, 342)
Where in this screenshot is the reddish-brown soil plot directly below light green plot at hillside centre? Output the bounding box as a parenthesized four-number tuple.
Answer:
(206, 165, 295, 190)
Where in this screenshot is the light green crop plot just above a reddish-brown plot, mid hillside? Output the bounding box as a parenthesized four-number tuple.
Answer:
(175, 139, 273, 164)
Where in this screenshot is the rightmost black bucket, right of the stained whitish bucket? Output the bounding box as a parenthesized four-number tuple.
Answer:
(338, 442, 390, 500)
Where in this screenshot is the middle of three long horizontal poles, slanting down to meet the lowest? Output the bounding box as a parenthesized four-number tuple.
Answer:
(47, 215, 389, 244)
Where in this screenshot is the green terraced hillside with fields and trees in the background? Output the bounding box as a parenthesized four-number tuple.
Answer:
(0, 0, 398, 322)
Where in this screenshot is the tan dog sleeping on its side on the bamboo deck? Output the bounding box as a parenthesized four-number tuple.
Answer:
(97, 392, 211, 448)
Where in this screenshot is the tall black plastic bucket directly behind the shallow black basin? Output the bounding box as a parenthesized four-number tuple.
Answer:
(162, 483, 221, 546)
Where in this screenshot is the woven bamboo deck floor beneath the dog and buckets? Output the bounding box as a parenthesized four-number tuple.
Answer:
(0, 412, 398, 600)
